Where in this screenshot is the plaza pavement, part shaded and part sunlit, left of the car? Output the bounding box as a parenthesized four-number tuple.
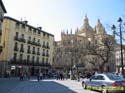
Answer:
(0, 78, 97, 93)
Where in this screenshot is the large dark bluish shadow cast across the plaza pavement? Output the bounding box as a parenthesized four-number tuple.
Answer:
(0, 79, 76, 93)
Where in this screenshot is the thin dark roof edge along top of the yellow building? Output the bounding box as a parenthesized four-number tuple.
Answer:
(4, 16, 54, 37)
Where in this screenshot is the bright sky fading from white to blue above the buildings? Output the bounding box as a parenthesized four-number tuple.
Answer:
(3, 0, 125, 41)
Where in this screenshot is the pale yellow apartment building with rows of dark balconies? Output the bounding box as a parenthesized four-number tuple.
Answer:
(0, 17, 54, 75)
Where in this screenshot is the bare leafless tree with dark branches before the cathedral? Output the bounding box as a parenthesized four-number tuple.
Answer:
(89, 37, 114, 72)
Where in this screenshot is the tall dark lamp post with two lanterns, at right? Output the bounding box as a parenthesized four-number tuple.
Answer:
(112, 18, 124, 75)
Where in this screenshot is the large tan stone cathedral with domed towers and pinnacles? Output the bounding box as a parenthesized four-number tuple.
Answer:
(54, 15, 115, 71)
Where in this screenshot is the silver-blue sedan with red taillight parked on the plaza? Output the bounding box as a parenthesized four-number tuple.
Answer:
(82, 73, 125, 93)
